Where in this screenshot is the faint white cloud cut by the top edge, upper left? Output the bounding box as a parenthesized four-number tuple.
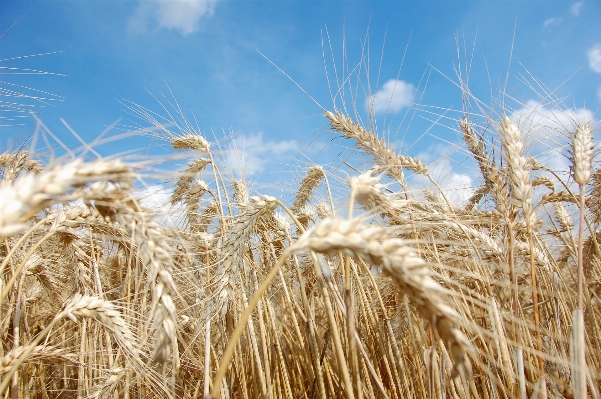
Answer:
(129, 0, 217, 36)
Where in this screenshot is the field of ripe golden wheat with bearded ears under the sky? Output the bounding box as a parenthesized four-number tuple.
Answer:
(0, 56, 601, 399)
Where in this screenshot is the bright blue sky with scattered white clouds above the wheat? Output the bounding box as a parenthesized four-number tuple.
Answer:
(0, 0, 601, 200)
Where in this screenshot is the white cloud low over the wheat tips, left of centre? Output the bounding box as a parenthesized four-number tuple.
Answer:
(224, 133, 296, 177)
